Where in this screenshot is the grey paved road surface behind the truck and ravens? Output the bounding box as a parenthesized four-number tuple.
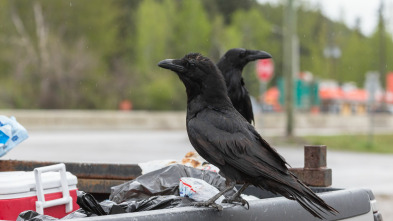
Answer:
(3, 130, 393, 195)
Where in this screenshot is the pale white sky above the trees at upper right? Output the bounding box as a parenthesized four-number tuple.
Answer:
(258, 0, 393, 35)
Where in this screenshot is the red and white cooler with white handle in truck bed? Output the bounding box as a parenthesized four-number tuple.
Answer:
(0, 169, 79, 220)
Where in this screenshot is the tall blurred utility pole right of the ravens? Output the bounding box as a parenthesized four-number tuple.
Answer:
(283, 0, 298, 137)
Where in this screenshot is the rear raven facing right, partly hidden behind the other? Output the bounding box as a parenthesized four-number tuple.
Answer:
(217, 48, 272, 123)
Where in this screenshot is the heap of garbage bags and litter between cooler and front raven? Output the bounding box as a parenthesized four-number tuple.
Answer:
(17, 155, 257, 221)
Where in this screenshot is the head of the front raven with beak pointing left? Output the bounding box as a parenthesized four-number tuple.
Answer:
(158, 53, 229, 105)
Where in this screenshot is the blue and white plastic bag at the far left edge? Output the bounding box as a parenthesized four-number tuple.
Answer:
(0, 115, 29, 157)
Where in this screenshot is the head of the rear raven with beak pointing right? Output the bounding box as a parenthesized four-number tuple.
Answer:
(219, 48, 272, 69)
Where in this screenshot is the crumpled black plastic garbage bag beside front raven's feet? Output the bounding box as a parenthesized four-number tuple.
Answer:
(109, 164, 235, 203)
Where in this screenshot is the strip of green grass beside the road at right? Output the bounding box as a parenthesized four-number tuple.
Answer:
(295, 134, 393, 153)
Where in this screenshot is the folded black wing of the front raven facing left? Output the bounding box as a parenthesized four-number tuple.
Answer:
(187, 108, 288, 177)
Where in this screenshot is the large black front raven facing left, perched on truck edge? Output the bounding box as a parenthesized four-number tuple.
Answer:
(158, 53, 337, 218)
